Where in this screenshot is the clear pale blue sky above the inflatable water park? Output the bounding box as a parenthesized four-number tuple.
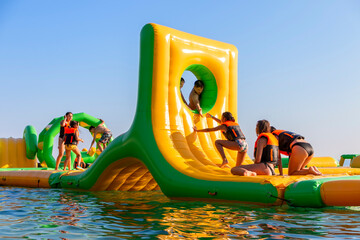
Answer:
(0, 0, 360, 159)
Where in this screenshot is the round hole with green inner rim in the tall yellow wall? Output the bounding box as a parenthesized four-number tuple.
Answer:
(180, 64, 217, 114)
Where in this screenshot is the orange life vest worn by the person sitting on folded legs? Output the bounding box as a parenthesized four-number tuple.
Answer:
(254, 133, 279, 165)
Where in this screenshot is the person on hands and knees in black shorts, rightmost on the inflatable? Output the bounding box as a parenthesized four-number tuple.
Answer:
(271, 127, 322, 175)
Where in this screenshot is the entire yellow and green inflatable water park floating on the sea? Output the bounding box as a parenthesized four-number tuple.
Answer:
(0, 23, 360, 207)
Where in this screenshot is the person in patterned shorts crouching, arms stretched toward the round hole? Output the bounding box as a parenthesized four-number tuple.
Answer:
(194, 112, 248, 168)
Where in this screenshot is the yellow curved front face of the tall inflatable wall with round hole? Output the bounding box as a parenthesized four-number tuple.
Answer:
(152, 24, 252, 181)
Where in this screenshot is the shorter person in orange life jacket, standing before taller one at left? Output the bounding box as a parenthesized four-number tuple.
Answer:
(64, 121, 84, 171)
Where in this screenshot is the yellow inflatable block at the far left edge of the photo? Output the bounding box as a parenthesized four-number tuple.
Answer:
(0, 138, 36, 168)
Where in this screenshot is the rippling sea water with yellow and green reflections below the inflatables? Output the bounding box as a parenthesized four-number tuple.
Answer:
(0, 187, 360, 239)
